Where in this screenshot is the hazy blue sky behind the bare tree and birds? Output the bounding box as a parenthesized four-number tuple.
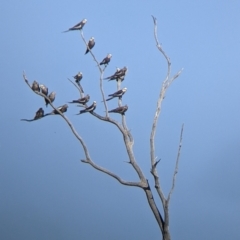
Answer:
(0, 0, 240, 240)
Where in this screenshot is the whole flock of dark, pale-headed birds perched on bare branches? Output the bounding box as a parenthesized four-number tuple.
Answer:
(21, 19, 128, 122)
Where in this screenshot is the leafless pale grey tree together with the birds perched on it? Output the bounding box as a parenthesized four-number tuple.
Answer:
(22, 16, 184, 240)
